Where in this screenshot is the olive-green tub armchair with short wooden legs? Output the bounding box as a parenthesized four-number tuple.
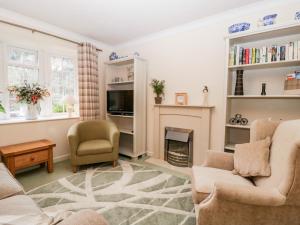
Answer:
(68, 120, 120, 173)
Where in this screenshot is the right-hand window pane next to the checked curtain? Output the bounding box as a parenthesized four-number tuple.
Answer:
(50, 57, 76, 113)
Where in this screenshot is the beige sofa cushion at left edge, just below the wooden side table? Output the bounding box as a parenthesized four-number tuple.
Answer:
(0, 163, 24, 199)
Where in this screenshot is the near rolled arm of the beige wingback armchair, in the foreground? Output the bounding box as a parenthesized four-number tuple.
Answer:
(212, 182, 286, 206)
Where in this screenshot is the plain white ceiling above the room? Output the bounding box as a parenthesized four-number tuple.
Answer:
(0, 0, 260, 45)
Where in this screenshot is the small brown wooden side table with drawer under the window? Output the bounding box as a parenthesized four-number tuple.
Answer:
(0, 139, 56, 175)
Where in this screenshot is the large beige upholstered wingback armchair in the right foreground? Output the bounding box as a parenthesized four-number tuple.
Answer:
(192, 120, 300, 225)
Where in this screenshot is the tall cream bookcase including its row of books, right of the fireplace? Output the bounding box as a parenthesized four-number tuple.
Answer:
(223, 23, 300, 152)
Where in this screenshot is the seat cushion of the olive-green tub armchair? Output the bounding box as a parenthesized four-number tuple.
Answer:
(77, 139, 113, 156)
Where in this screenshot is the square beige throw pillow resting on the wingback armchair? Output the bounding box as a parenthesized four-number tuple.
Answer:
(233, 137, 271, 177)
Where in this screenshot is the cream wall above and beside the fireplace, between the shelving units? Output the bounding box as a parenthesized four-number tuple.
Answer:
(116, 1, 300, 154)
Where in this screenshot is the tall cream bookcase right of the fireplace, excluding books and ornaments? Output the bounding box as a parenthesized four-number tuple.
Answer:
(224, 23, 300, 152)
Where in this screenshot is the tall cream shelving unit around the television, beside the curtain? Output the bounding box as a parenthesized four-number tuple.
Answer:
(105, 57, 147, 158)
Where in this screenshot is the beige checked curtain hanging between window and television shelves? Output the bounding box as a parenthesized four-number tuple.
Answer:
(78, 43, 100, 120)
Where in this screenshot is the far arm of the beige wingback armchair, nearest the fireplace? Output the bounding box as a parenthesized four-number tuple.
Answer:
(202, 150, 234, 170)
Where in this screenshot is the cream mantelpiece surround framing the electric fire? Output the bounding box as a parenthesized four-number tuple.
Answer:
(152, 105, 214, 165)
